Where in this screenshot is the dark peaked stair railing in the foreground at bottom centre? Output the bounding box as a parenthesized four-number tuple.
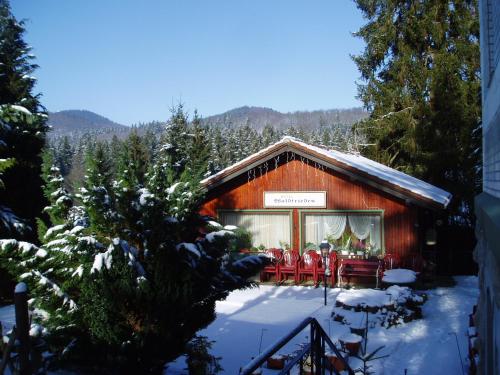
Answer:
(240, 317, 354, 375)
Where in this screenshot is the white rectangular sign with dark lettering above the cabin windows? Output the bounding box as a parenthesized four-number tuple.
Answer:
(264, 191, 326, 208)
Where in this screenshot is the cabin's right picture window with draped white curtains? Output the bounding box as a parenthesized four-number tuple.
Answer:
(303, 211, 384, 255)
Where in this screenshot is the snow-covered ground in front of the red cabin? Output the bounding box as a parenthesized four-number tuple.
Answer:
(167, 276, 479, 375)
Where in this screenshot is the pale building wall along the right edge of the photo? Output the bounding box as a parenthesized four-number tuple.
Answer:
(474, 0, 500, 375)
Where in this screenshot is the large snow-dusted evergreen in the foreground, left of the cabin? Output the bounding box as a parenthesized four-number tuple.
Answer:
(0, 130, 265, 374)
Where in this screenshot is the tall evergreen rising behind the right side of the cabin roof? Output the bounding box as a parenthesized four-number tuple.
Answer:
(354, 0, 481, 227)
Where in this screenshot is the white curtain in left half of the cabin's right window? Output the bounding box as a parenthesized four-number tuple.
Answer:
(304, 214, 347, 245)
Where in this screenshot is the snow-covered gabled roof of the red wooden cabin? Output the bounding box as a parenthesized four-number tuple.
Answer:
(201, 137, 452, 208)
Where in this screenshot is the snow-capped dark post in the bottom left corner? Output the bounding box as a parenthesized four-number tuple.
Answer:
(14, 283, 31, 375)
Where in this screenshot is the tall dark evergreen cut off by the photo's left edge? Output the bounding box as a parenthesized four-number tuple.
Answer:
(0, 0, 47, 240)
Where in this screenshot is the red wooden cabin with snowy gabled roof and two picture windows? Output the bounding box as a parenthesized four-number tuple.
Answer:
(198, 137, 451, 262)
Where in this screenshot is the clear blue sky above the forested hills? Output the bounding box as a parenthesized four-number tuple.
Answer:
(11, 0, 363, 125)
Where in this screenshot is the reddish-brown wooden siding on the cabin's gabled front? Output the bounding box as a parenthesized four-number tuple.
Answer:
(202, 155, 418, 255)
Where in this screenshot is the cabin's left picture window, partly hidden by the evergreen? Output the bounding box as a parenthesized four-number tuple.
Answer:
(219, 211, 291, 249)
